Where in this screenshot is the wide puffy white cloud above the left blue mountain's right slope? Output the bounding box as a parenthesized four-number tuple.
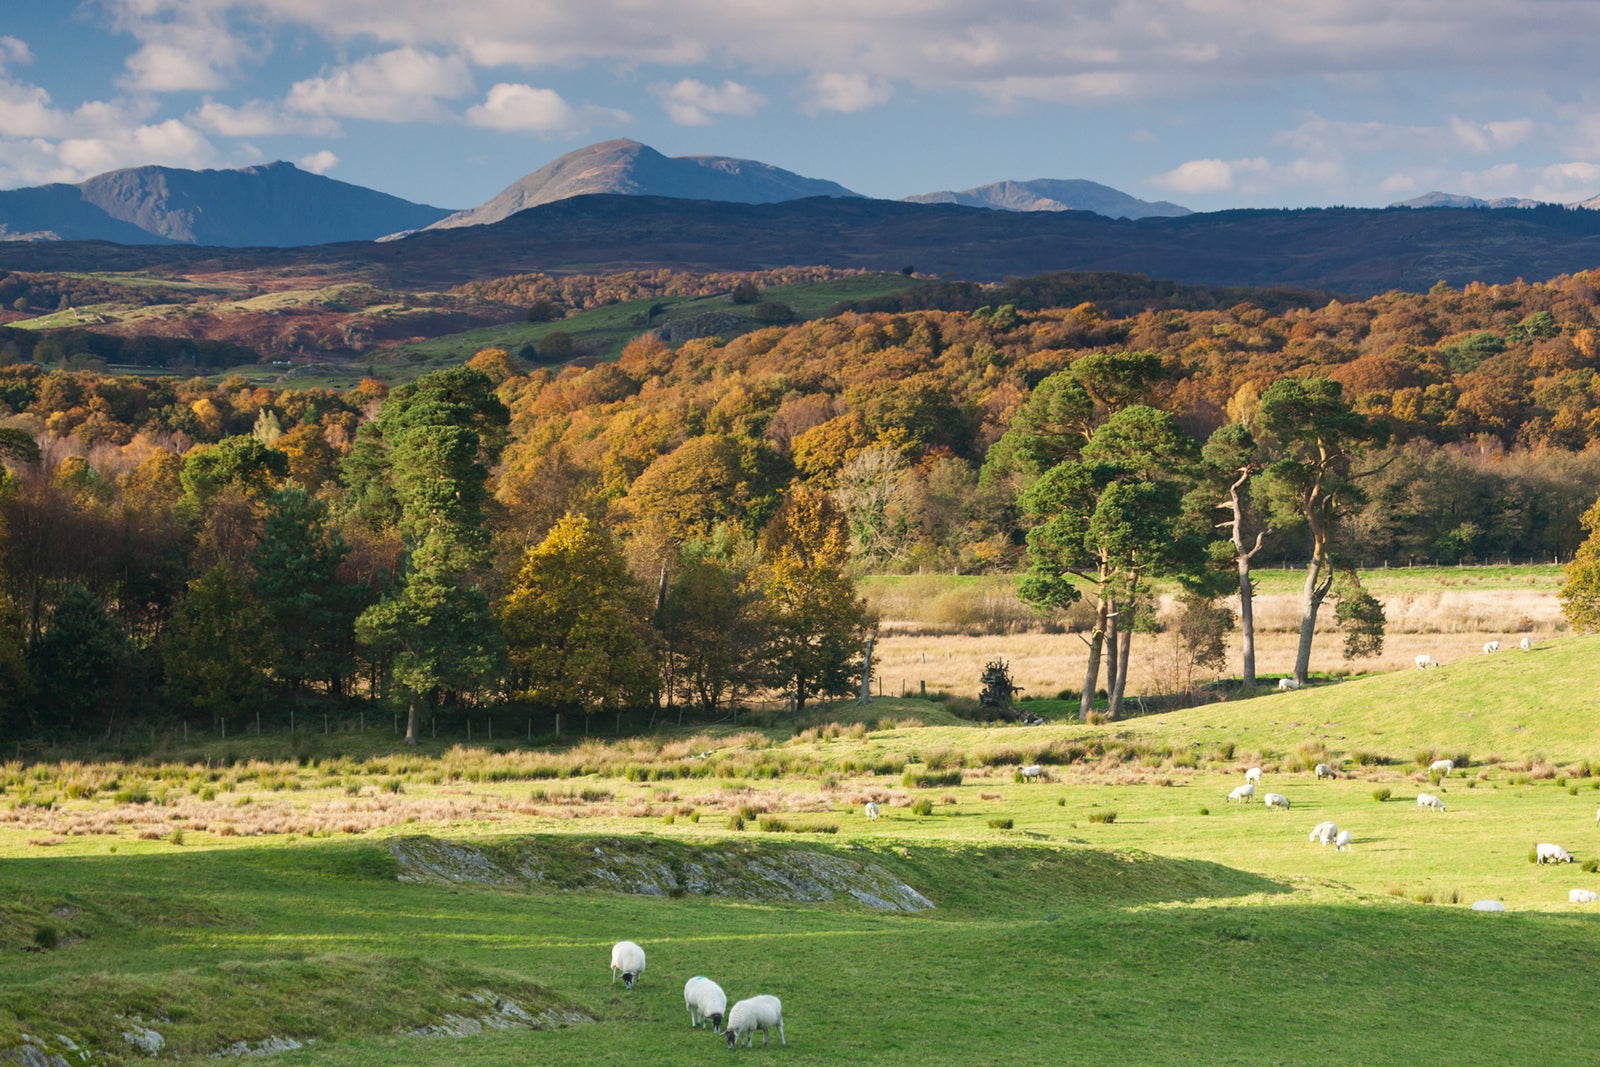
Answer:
(286, 48, 472, 122)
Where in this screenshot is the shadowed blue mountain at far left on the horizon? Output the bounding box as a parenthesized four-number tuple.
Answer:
(0, 162, 445, 246)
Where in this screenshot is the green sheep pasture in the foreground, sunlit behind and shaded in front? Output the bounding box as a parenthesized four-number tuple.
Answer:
(0, 637, 1600, 1067)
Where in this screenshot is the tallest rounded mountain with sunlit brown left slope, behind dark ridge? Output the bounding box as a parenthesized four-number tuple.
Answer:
(427, 139, 859, 229)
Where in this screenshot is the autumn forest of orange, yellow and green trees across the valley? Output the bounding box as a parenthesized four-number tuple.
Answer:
(0, 274, 1600, 744)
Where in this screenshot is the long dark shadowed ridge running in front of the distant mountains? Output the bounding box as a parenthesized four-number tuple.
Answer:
(0, 195, 1600, 294)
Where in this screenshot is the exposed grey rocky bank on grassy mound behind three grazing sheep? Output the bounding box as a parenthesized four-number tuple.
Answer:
(389, 837, 934, 912)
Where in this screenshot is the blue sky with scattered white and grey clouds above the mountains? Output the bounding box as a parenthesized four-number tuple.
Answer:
(0, 0, 1600, 211)
